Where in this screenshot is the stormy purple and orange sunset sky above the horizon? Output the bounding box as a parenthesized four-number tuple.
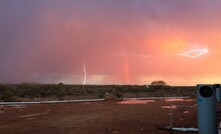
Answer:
(0, 0, 221, 86)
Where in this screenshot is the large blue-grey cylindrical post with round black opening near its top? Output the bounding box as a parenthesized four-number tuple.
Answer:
(197, 84, 218, 134)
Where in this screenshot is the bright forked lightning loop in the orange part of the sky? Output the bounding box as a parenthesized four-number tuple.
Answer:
(177, 48, 209, 58)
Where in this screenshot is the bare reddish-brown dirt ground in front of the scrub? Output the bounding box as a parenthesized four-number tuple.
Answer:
(0, 99, 197, 134)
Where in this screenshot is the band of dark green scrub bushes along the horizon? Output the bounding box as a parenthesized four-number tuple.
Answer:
(0, 83, 196, 102)
